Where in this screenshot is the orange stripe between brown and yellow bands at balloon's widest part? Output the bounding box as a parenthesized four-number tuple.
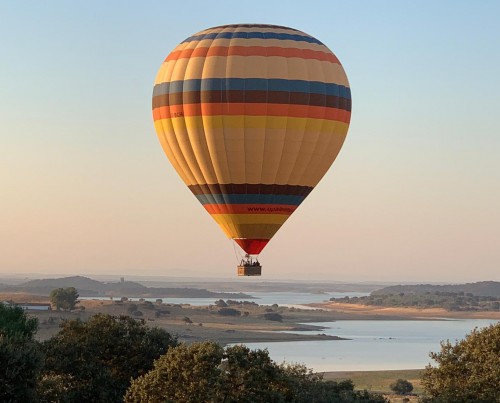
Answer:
(153, 103, 351, 123)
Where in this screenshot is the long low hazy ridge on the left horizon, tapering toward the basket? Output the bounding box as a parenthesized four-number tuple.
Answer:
(0, 276, 253, 299)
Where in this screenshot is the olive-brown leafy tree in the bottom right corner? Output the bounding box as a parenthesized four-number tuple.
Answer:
(422, 323, 500, 403)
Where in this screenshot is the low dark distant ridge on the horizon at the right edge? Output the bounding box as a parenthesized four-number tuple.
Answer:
(371, 281, 500, 297)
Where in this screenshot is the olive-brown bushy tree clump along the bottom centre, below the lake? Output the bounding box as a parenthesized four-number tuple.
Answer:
(125, 342, 385, 403)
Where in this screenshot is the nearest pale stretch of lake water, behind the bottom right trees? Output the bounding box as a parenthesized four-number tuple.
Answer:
(246, 319, 498, 372)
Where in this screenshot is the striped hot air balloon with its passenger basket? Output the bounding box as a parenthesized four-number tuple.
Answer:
(153, 24, 351, 275)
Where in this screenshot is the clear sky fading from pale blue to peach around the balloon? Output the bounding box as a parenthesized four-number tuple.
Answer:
(0, 0, 500, 283)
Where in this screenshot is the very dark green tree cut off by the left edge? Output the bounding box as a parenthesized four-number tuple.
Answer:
(0, 304, 43, 402)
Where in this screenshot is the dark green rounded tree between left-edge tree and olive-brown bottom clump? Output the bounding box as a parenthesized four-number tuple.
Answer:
(41, 314, 177, 402)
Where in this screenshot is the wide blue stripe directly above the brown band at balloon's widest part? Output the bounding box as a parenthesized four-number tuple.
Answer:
(153, 78, 351, 99)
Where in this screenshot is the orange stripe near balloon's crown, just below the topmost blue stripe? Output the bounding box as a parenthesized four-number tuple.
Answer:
(165, 46, 340, 64)
